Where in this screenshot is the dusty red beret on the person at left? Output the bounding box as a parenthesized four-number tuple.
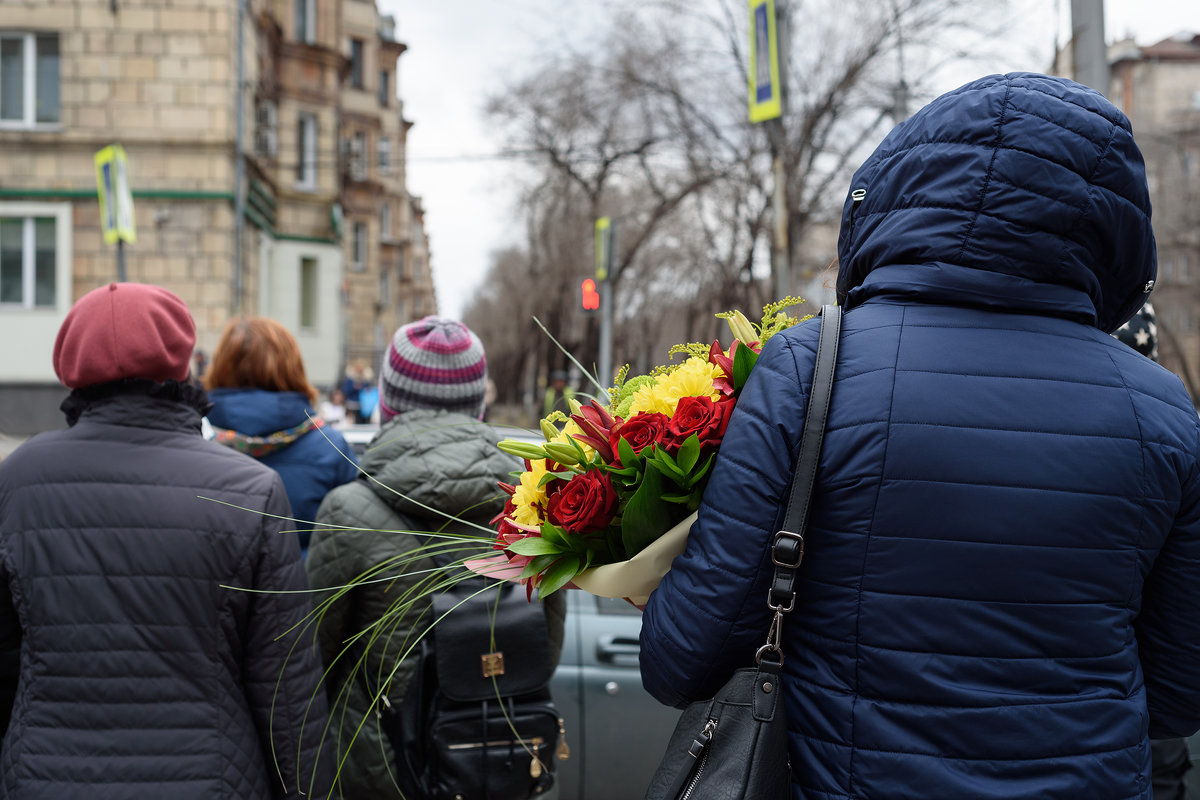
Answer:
(54, 283, 196, 389)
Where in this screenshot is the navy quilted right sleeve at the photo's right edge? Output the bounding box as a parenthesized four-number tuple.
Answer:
(1136, 423, 1200, 739)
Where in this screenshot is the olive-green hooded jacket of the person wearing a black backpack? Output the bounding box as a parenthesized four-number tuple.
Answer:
(305, 410, 566, 800)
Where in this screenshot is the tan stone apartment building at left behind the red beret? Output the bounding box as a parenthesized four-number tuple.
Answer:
(0, 0, 436, 433)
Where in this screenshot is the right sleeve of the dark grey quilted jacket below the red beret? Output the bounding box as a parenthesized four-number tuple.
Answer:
(242, 479, 331, 799)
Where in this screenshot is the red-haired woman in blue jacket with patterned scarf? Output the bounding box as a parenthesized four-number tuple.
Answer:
(204, 317, 359, 557)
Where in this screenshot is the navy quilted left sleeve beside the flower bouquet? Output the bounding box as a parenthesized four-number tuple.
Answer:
(641, 331, 817, 706)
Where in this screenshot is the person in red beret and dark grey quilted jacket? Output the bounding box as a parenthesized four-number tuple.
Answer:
(0, 283, 332, 800)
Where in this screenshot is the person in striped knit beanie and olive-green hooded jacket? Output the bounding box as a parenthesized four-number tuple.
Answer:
(305, 317, 566, 798)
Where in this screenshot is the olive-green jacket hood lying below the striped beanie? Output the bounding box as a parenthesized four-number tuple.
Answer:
(360, 409, 521, 530)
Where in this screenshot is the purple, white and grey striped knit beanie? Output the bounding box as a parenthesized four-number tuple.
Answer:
(379, 317, 487, 422)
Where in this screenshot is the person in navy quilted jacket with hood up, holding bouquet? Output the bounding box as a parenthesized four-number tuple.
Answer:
(641, 74, 1200, 800)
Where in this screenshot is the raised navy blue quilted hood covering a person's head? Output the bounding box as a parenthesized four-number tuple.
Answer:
(838, 73, 1157, 332)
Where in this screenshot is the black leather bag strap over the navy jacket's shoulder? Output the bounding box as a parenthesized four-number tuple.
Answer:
(754, 306, 841, 720)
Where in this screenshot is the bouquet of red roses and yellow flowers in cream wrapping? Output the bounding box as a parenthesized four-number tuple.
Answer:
(466, 297, 802, 606)
